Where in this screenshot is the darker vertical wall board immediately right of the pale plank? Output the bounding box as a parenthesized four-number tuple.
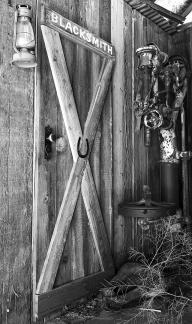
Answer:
(119, 4, 137, 263)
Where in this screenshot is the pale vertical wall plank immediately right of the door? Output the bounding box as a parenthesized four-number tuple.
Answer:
(111, 0, 125, 263)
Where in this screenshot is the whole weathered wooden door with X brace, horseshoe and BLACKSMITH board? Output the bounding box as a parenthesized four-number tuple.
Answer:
(33, 2, 114, 319)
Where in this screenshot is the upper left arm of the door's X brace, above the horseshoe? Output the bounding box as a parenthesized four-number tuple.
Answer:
(41, 26, 82, 161)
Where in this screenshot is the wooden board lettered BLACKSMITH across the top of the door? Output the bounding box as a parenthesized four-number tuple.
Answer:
(41, 5, 115, 58)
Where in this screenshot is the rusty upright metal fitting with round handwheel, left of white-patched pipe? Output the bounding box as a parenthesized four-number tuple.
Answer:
(134, 43, 168, 146)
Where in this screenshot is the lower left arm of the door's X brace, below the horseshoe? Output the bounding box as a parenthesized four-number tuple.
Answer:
(36, 158, 87, 294)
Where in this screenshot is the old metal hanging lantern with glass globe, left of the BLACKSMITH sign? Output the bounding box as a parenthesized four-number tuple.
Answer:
(12, 4, 37, 68)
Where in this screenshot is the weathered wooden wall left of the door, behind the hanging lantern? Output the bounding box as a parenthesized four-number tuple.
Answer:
(0, 0, 33, 324)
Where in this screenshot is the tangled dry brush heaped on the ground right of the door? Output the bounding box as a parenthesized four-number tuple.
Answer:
(102, 217, 192, 324)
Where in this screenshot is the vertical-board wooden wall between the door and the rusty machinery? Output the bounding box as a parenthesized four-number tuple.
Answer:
(111, 0, 172, 266)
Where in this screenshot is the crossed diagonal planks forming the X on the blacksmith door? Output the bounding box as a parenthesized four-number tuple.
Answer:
(37, 26, 114, 293)
